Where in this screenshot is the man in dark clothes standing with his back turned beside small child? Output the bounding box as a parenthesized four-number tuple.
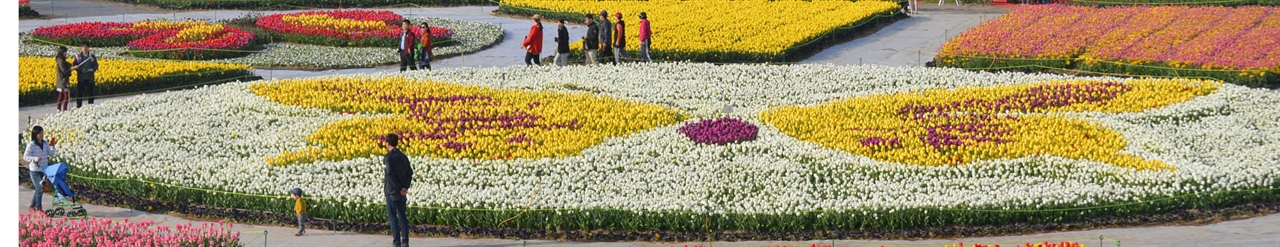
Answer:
(383, 134, 413, 247)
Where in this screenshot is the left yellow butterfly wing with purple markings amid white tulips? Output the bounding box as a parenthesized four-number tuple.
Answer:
(251, 77, 684, 165)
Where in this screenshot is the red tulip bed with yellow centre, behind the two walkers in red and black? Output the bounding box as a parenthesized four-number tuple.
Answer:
(257, 10, 453, 47)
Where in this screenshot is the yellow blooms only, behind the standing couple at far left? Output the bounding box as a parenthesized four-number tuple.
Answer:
(18, 56, 250, 95)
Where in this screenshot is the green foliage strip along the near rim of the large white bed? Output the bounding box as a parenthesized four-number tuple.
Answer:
(19, 163, 1280, 239)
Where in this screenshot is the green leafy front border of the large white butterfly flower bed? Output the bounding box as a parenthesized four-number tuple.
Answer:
(18, 166, 1280, 241)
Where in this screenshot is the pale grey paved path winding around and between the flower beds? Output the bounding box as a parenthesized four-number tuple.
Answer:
(18, 0, 1280, 247)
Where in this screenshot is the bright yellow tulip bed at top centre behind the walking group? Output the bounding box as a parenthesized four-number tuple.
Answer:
(499, 0, 901, 61)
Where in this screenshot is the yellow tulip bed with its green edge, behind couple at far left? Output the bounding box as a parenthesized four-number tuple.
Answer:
(18, 56, 255, 106)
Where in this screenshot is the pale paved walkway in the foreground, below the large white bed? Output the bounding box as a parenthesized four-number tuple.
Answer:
(17, 187, 1280, 247)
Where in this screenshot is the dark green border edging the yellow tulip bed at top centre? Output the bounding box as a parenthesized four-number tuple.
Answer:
(494, 1, 906, 63)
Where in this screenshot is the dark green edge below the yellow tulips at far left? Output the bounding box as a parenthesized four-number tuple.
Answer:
(18, 69, 260, 106)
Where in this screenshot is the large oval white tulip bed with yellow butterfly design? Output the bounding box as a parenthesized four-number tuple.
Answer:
(33, 63, 1280, 239)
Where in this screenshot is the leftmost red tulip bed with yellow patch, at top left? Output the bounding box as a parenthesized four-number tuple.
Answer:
(31, 20, 255, 59)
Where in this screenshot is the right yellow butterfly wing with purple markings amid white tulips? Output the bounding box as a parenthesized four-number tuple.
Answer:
(760, 79, 1221, 170)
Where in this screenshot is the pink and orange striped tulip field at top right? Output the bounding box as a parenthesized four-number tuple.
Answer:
(936, 5, 1280, 86)
